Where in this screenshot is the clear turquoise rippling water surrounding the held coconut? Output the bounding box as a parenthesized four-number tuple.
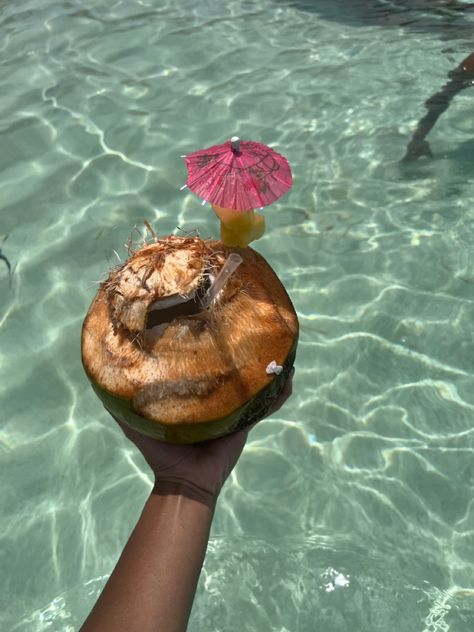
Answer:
(0, 0, 474, 632)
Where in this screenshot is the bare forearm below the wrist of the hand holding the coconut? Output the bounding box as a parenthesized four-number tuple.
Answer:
(81, 486, 213, 632)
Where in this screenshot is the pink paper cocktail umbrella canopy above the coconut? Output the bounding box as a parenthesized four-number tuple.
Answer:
(183, 136, 293, 211)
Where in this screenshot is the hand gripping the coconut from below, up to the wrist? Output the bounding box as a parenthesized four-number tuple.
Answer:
(114, 370, 294, 504)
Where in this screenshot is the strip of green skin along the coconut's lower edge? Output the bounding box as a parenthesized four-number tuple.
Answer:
(88, 339, 298, 444)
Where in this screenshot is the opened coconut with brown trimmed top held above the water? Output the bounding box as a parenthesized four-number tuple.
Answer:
(82, 236, 298, 443)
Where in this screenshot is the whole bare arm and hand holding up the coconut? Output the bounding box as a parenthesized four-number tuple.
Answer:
(81, 373, 293, 632)
